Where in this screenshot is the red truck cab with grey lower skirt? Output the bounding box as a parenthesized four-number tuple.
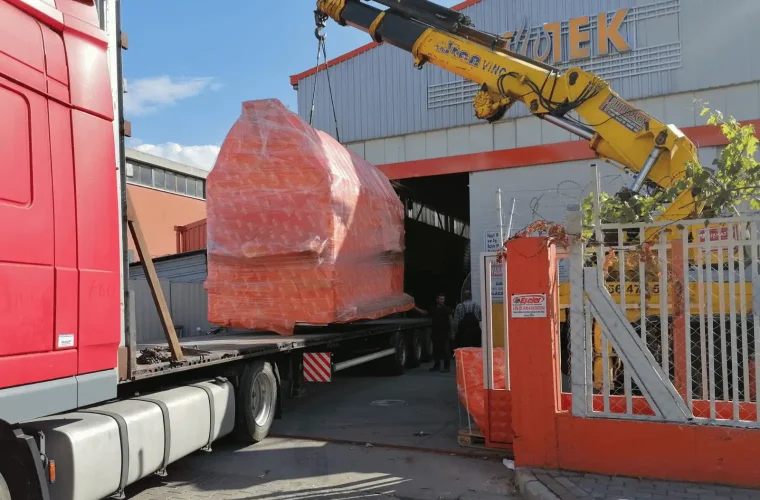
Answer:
(0, 0, 122, 424)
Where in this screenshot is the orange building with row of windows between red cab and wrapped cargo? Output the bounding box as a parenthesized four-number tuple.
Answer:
(126, 148, 208, 262)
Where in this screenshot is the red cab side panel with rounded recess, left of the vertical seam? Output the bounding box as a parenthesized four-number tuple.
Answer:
(0, 2, 77, 388)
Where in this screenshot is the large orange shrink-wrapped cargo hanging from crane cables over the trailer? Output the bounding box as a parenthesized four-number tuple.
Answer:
(206, 99, 414, 335)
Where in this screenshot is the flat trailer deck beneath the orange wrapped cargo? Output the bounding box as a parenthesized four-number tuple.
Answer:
(127, 318, 430, 383)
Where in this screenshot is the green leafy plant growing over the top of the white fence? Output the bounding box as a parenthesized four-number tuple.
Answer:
(582, 106, 760, 237)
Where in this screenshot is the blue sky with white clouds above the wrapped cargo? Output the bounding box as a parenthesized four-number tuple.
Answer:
(122, 0, 458, 168)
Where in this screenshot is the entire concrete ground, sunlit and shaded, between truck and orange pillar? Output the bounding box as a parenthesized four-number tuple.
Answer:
(127, 364, 519, 500)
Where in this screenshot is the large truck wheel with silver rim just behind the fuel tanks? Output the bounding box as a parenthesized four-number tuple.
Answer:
(235, 360, 279, 444)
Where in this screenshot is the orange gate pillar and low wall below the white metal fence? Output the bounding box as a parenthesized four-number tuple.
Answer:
(506, 238, 760, 487)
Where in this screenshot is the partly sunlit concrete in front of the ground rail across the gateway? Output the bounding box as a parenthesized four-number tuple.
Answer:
(127, 438, 519, 500)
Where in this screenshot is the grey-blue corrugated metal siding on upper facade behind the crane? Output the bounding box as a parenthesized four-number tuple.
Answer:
(298, 0, 760, 142)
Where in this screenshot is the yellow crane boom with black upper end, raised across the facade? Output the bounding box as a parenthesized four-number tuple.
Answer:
(315, 0, 701, 220)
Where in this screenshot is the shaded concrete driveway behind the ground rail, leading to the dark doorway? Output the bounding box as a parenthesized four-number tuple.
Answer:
(271, 363, 476, 453)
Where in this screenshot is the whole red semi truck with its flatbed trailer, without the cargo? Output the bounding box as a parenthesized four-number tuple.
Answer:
(0, 0, 431, 500)
